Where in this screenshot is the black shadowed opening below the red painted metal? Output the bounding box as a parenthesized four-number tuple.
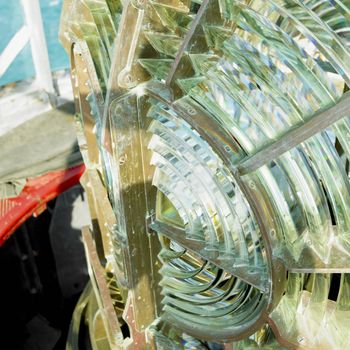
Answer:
(0, 185, 88, 350)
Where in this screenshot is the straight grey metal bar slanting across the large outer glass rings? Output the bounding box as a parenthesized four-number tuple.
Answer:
(237, 92, 350, 176)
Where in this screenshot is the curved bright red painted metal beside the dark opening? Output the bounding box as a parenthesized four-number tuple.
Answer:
(0, 164, 85, 246)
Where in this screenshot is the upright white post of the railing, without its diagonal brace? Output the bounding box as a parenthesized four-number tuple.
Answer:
(22, 0, 55, 94)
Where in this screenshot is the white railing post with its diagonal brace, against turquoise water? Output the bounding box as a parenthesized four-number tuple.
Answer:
(0, 0, 56, 95)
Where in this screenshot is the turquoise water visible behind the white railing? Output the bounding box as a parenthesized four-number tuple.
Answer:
(0, 0, 69, 86)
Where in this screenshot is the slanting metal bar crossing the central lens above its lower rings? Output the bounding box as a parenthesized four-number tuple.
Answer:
(149, 221, 268, 293)
